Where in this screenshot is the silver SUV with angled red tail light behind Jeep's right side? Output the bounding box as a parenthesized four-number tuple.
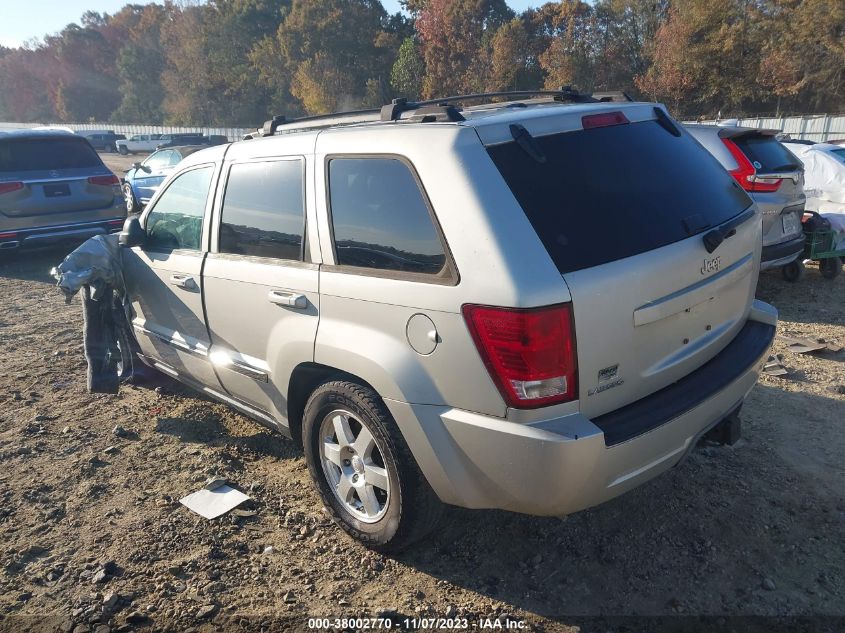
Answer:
(685, 125, 806, 276)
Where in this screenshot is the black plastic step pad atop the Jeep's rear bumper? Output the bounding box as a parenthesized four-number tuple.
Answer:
(592, 321, 775, 447)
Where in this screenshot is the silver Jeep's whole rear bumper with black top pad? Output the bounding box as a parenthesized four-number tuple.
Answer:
(386, 301, 777, 516)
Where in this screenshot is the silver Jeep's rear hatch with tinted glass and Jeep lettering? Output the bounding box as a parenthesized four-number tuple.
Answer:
(488, 105, 760, 416)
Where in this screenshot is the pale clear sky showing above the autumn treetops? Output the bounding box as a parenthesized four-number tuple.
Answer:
(0, 0, 543, 46)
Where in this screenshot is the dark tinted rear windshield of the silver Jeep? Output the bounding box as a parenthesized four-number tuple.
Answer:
(488, 121, 751, 273)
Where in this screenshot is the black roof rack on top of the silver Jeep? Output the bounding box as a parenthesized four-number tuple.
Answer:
(244, 86, 612, 140)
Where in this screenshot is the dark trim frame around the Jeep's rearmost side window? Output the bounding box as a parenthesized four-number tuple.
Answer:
(323, 153, 460, 286)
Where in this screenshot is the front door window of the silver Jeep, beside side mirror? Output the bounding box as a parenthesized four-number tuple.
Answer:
(146, 166, 214, 250)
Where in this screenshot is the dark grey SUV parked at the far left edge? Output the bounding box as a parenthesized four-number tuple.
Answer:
(0, 130, 126, 252)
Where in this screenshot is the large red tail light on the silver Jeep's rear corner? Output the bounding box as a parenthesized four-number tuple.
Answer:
(463, 303, 578, 409)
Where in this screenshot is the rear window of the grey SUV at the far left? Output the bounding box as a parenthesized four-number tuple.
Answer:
(0, 137, 103, 172)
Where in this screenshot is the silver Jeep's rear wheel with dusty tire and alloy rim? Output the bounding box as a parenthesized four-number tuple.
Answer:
(302, 380, 443, 552)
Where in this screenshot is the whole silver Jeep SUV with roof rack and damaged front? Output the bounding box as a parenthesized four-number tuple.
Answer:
(121, 93, 777, 550)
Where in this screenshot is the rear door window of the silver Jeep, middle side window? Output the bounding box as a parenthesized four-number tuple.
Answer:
(220, 160, 305, 260)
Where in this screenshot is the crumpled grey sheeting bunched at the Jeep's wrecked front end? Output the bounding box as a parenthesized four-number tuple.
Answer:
(52, 233, 125, 302)
